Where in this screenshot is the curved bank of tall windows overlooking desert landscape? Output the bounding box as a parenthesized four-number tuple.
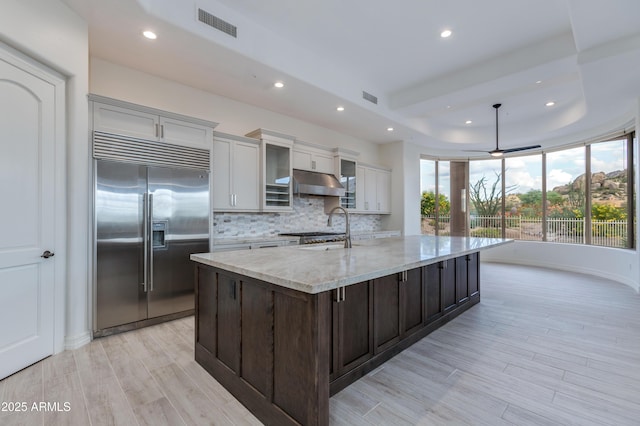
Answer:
(421, 134, 636, 248)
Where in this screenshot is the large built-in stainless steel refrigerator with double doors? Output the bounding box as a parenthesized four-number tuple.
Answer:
(94, 131, 210, 336)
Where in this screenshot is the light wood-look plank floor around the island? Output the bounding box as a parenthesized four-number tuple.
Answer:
(0, 264, 640, 426)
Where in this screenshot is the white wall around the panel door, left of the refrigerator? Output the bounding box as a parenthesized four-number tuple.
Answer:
(0, 0, 90, 352)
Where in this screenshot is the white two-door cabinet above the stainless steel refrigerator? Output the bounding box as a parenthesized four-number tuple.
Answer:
(89, 95, 217, 149)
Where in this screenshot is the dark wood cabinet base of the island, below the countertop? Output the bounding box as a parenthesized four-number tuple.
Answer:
(194, 236, 510, 425)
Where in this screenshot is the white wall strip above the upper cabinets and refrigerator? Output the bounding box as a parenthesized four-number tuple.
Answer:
(89, 57, 380, 166)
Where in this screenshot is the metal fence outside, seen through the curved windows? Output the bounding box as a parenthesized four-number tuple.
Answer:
(422, 216, 627, 248)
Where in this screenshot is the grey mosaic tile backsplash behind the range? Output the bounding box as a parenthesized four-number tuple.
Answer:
(213, 195, 382, 238)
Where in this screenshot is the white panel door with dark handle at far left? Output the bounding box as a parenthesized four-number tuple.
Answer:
(0, 46, 57, 379)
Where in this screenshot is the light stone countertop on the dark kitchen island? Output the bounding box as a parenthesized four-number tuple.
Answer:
(191, 235, 513, 294)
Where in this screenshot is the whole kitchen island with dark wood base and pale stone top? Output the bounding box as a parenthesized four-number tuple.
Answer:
(191, 236, 510, 425)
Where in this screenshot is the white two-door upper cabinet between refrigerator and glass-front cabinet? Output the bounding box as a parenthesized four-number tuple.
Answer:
(212, 132, 260, 212)
